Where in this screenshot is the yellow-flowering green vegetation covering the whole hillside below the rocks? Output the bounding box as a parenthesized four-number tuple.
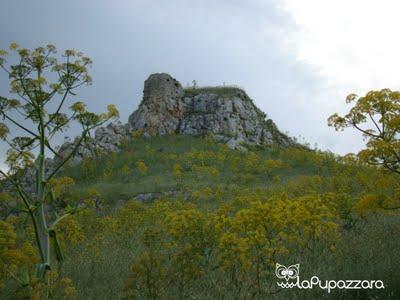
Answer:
(0, 134, 400, 299)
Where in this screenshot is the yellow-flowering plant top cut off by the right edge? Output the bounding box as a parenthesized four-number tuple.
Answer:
(328, 89, 400, 174)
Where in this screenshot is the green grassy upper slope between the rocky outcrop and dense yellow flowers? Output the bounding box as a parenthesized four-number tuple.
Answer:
(63, 136, 344, 203)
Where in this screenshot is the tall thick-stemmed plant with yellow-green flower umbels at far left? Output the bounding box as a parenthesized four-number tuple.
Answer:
(0, 43, 118, 279)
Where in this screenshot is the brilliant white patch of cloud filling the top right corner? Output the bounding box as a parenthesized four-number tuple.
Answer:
(283, 0, 400, 92)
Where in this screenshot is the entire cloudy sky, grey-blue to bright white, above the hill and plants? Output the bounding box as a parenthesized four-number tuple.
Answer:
(0, 0, 400, 170)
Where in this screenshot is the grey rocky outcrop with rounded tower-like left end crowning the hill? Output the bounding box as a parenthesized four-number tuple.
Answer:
(128, 73, 292, 148)
